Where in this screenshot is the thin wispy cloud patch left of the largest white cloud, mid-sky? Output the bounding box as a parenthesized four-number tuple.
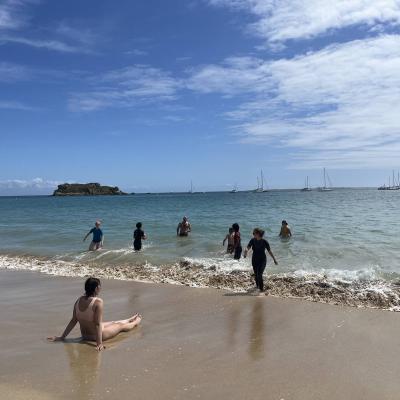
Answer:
(69, 64, 181, 111)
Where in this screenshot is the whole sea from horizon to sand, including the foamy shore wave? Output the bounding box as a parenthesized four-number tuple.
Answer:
(0, 189, 400, 310)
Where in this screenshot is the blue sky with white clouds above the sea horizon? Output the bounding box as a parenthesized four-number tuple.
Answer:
(0, 0, 400, 195)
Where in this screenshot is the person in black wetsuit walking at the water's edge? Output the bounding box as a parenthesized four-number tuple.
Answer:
(243, 228, 278, 293)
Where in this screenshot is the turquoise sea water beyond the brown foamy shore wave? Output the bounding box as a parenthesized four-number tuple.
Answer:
(0, 189, 400, 278)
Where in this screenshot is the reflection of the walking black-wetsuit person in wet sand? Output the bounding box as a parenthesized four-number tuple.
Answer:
(248, 298, 266, 360)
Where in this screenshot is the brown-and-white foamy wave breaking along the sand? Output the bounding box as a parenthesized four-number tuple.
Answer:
(0, 254, 400, 311)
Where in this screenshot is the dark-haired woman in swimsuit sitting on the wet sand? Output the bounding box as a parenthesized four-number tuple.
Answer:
(48, 278, 142, 351)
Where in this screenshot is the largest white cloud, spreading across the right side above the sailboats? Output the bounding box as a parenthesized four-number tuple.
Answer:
(186, 35, 400, 167)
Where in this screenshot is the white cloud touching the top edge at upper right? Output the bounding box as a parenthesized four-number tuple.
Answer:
(208, 0, 400, 43)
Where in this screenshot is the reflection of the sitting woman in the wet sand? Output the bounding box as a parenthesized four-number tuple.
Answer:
(64, 343, 102, 399)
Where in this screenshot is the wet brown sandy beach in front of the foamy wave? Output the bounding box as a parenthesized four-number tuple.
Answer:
(0, 270, 400, 400)
